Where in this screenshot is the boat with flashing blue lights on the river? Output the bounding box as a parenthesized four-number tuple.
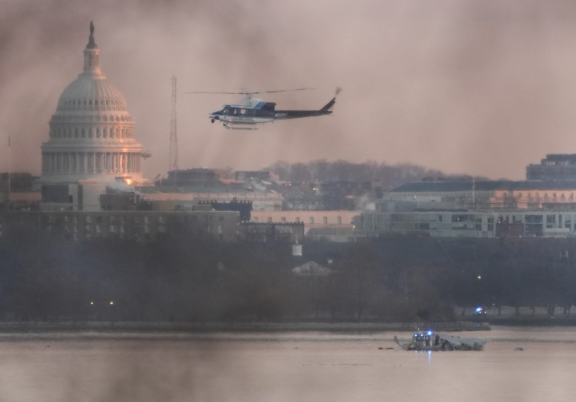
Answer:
(394, 331, 488, 351)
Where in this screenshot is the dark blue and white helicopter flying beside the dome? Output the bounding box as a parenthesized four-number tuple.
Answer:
(186, 88, 342, 130)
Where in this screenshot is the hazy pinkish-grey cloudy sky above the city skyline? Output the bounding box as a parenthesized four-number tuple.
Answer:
(0, 0, 576, 179)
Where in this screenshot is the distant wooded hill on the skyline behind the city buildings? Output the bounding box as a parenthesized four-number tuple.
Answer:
(268, 160, 480, 190)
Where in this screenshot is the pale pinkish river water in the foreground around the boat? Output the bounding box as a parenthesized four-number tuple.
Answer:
(0, 328, 576, 402)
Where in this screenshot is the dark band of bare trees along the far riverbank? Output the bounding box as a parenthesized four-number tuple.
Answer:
(0, 228, 576, 322)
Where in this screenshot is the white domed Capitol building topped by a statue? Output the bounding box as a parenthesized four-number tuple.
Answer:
(39, 23, 151, 211)
